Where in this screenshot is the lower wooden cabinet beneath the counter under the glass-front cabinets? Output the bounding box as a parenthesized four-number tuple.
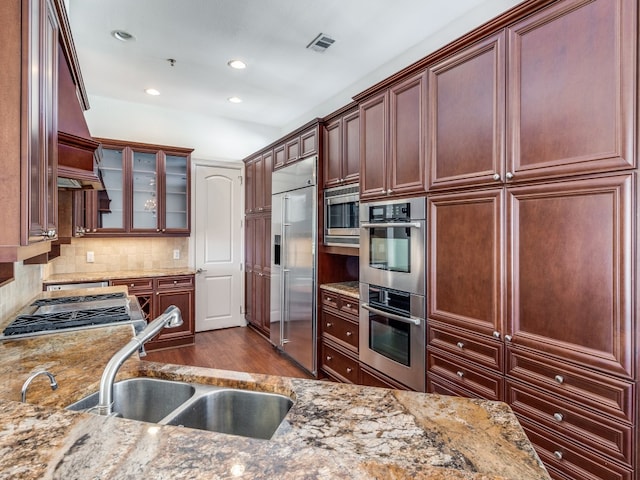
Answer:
(110, 275, 195, 351)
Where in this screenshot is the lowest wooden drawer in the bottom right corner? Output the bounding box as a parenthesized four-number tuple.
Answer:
(516, 415, 633, 480)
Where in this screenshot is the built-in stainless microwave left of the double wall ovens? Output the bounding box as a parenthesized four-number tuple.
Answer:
(324, 184, 360, 247)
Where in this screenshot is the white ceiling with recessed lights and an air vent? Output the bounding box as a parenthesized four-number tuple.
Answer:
(67, 0, 517, 128)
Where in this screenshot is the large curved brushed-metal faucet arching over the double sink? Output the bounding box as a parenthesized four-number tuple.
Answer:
(91, 305, 182, 415)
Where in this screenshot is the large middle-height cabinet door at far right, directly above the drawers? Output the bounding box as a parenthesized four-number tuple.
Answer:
(507, 175, 634, 377)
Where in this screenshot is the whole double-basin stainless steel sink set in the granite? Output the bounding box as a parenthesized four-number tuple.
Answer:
(67, 377, 293, 440)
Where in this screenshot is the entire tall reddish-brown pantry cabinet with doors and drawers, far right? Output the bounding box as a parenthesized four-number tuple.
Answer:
(426, 0, 638, 480)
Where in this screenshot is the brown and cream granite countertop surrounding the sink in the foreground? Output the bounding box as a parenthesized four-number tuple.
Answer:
(0, 288, 549, 480)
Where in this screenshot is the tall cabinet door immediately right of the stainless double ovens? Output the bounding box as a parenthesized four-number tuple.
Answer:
(428, 189, 505, 336)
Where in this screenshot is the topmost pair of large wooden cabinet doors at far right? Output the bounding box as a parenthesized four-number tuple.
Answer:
(426, 0, 636, 189)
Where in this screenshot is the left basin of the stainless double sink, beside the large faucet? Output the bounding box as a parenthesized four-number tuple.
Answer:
(67, 378, 196, 423)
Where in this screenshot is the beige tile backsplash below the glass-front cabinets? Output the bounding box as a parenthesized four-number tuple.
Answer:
(45, 237, 189, 278)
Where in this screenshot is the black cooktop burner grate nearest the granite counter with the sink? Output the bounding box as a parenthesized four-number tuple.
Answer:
(3, 306, 131, 336)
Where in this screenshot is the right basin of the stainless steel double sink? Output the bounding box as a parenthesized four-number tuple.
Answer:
(166, 390, 293, 440)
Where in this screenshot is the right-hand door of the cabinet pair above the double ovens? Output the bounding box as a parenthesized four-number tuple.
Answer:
(387, 74, 426, 194)
